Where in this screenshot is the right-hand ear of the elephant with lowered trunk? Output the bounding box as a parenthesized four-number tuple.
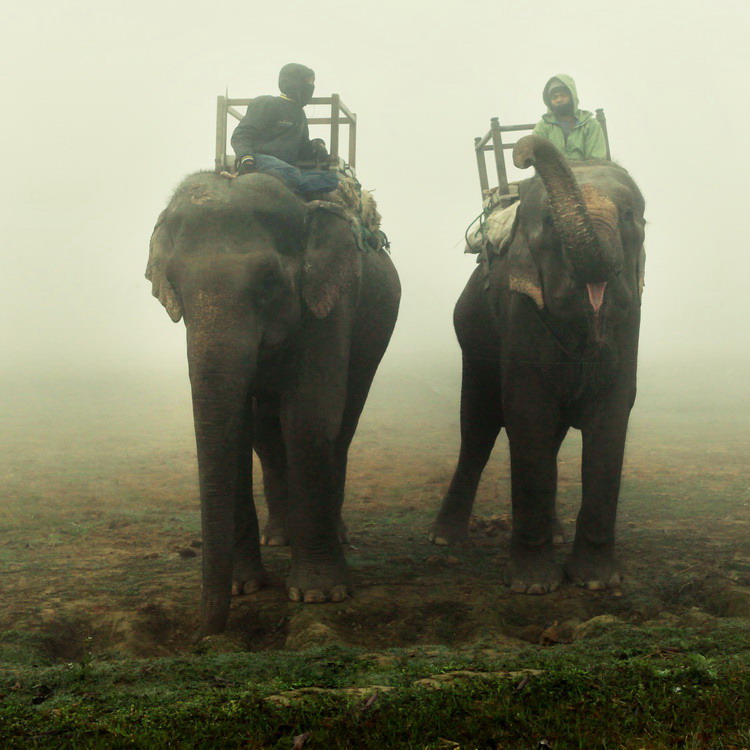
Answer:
(302, 208, 362, 318)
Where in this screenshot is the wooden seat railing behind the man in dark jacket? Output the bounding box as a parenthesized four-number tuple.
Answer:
(214, 94, 357, 172)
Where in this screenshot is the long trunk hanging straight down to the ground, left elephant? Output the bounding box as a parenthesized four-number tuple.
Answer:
(188, 327, 257, 635)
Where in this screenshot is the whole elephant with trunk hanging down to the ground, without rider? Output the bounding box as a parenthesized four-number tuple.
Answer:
(146, 172, 400, 635)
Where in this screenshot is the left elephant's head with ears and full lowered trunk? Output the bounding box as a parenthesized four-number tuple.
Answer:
(146, 172, 362, 632)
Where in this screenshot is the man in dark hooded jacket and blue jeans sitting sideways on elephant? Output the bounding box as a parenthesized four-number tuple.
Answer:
(232, 63, 338, 194)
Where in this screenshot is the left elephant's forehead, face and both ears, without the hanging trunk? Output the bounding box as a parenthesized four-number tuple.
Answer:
(146, 172, 361, 328)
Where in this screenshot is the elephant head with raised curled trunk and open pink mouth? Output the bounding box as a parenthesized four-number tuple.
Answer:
(508, 135, 645, 341)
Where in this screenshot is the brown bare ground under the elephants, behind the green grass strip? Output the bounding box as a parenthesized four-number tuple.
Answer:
(0, 360, 750, 661)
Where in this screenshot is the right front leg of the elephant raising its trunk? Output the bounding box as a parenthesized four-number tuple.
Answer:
(565, 407, 629, 590)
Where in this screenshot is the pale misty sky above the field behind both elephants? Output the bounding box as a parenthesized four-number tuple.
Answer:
(0, 0, 750, 371)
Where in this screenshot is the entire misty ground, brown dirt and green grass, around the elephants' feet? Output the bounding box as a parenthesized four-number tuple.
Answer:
(0, 362, 750, 748)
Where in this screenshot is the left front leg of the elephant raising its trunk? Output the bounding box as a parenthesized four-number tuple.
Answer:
(506, 414, 567, 594)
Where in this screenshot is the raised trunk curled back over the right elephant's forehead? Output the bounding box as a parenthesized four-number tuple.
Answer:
(513, 135, 621, 284)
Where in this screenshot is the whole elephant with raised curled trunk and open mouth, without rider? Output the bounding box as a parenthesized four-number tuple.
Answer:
(429, 135, 645, 594)
